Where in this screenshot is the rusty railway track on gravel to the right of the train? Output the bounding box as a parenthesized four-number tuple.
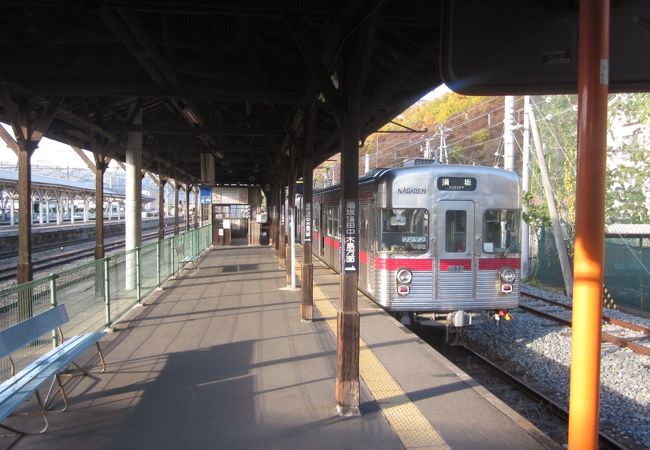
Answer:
(519, 292, 650, 356)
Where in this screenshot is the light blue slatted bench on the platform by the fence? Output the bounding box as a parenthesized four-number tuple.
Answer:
(0, 305, 106, 435)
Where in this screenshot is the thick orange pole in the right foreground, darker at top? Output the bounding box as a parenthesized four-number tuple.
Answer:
(569, 0, 609, 450)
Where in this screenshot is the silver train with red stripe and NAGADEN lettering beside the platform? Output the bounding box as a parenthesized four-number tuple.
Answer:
(312, 164, 521, 326)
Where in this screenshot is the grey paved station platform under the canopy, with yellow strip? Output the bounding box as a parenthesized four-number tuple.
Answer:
(0, 246, 558, 450)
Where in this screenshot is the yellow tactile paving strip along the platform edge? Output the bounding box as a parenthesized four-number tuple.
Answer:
(314, 285, 451, 449)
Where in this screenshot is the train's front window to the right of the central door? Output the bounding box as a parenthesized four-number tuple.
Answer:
(483, 209, 521, 256)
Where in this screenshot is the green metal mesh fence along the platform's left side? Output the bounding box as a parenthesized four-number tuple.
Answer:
(0, 225, 212, 380)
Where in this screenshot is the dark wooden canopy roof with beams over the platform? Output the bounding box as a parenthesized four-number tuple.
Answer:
(0, 0, 649, 185)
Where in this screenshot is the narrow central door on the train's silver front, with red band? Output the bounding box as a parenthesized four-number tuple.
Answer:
(435, 201, 475, 304)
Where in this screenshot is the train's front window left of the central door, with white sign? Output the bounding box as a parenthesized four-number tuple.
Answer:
(378, 208, 429, 253)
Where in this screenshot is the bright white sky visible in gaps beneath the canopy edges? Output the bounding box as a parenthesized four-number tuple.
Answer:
(0, 84, 450, 168)
